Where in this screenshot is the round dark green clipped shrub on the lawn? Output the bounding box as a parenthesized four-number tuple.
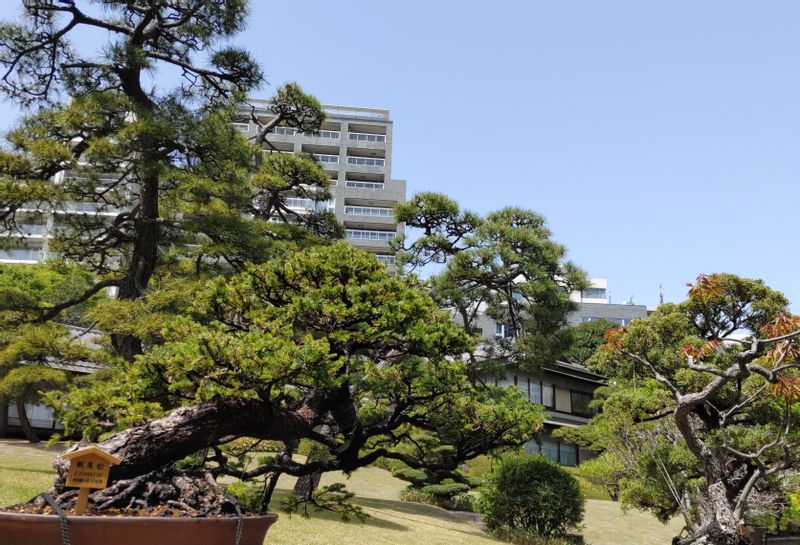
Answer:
(478, 456, 586, 537)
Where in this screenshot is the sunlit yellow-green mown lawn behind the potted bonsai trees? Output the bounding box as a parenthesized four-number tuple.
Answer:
(0, 440, 680, 545)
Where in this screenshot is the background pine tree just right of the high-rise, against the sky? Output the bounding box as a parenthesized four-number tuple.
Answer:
(395, 193, 586, 368)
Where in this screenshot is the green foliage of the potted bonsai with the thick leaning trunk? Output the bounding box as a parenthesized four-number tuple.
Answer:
(51, 243, 543, 484)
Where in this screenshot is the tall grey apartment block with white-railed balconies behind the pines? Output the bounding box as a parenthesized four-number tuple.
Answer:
(0, 100, 406, 270)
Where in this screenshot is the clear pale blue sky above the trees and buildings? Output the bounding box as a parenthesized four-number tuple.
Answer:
(0, 0, 800, 306)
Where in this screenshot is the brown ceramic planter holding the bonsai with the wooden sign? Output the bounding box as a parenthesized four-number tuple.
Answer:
(0, 512, 278, 545)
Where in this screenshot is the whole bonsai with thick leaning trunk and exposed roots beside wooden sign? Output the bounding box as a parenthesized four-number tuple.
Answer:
(43, 243, 542, 513)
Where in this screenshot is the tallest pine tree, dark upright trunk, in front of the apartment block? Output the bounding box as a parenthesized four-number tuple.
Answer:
(0, 0, 340, 360)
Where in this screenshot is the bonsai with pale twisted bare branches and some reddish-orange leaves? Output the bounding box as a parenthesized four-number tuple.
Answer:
(573, 274, 800, 545)
